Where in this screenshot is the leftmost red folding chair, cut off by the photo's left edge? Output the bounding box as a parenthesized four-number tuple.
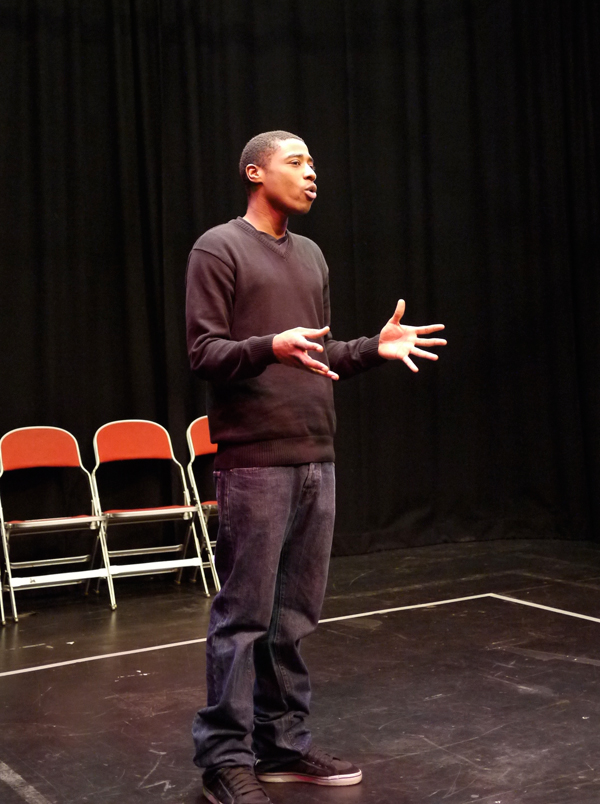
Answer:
(0, 427, 116, 625)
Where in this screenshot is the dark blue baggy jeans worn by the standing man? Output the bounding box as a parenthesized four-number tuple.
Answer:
(192, 463, 335, 768)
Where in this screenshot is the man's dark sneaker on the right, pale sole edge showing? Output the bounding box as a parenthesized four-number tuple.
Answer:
(254, 747, 362, 787)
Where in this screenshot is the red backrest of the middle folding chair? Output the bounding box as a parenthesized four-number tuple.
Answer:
(94, 419, 177, 466)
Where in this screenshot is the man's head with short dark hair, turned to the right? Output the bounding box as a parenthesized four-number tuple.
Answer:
(240, 131, 317, 215)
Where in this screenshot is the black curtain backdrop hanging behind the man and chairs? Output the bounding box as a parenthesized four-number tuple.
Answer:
(0, 0, 600, 553)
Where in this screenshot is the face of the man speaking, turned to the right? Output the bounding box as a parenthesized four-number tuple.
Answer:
(251, 140, 317, 215)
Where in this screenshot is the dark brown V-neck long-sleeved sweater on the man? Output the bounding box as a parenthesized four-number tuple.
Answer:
(187, 218, 385, 469)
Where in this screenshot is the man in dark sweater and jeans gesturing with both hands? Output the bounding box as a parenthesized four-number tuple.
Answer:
(187, 131, 445, 804)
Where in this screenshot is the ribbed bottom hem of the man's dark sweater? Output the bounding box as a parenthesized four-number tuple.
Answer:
(214, 436, 335, 469)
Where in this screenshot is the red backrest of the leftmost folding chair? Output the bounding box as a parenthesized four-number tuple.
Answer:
(0, 427, 83, 474)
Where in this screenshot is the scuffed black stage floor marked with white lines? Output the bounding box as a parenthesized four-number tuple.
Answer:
(0, 541, 600, 804)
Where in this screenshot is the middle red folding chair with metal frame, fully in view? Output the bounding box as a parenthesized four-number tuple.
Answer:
(92, 419, 208, 596)
